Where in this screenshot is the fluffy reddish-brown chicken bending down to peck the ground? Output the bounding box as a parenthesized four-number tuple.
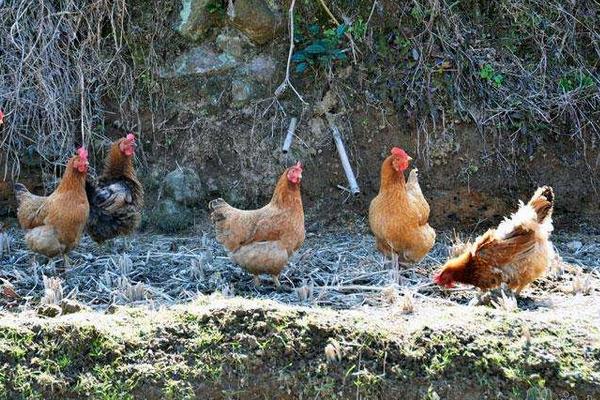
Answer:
(433, 186, 554, 294)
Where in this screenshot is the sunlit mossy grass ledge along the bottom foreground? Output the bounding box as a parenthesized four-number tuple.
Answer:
(0, 298, 600, 399)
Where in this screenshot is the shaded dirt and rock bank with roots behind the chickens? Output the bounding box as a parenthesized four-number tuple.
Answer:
(0, 0, 600, 233)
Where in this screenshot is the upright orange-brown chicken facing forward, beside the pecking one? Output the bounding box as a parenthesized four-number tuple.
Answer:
(369, 147, 435, 263)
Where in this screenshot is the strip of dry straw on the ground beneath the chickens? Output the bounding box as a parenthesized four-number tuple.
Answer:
(0, 222, 600, 314)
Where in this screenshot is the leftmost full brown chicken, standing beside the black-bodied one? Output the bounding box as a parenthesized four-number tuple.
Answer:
(15, 147, 89, 266)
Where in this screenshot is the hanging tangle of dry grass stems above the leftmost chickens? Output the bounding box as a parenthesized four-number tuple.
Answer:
(0, 0, 134, 181)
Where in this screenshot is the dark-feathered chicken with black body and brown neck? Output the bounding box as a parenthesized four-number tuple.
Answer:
(85, 133, 144, 243)
